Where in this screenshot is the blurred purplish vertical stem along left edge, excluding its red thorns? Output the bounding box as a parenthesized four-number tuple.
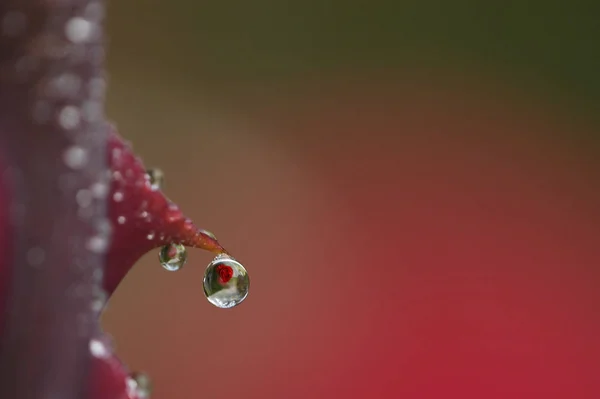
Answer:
(0, 0, 109, 399)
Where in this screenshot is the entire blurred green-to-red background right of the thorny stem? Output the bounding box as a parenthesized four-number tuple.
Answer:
(103, 0, 600, 399)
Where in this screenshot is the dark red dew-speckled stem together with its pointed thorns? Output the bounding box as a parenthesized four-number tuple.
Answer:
(0, 0, 225, 399)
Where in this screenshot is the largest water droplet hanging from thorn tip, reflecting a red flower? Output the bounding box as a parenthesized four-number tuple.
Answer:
(204, 254, 250, 309)
